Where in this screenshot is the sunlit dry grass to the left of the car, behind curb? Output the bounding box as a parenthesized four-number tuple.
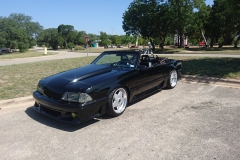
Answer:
(0, 57, 96, 100)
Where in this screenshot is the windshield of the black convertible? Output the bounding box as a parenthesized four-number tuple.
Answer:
(92, 52, 138, 68)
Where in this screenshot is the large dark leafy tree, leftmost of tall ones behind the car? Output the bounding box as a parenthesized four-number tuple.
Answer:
(123, 0, 173, 48)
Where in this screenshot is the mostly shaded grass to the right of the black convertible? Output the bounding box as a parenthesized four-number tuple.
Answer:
(161, 56, 240, 80)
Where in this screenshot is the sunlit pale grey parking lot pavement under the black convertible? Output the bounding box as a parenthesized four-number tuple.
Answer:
(0, 82, 240, 160)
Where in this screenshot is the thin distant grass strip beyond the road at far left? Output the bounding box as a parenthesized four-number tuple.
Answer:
(0, 51, 58, 59)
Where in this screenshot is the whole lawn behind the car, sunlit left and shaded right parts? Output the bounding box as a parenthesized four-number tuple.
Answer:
(0, 55, 240, 100)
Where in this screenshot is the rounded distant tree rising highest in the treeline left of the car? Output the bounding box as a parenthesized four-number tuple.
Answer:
(58, 24, 74, 48)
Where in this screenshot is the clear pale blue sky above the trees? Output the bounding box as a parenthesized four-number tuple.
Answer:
(0, 0, 213, 35)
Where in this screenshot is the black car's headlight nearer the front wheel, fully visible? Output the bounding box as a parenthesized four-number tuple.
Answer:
(62, 92, 92, 103)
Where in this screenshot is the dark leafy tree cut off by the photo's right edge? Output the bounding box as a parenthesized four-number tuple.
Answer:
(208, 0, 240, 48)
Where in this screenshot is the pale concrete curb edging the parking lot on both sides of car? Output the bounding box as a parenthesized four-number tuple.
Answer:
(0, 75, 240, 109)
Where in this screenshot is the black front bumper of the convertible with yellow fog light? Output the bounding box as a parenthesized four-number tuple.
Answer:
(33, 91, 107, 124)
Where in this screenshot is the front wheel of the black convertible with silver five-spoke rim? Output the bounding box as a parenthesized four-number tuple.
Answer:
(107, 87, 128, 117)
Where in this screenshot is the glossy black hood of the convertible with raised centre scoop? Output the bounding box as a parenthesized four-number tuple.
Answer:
(40, 64, 125, 94)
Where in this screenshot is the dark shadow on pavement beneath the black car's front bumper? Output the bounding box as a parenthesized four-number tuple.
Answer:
(25, 107, 99, 132)
